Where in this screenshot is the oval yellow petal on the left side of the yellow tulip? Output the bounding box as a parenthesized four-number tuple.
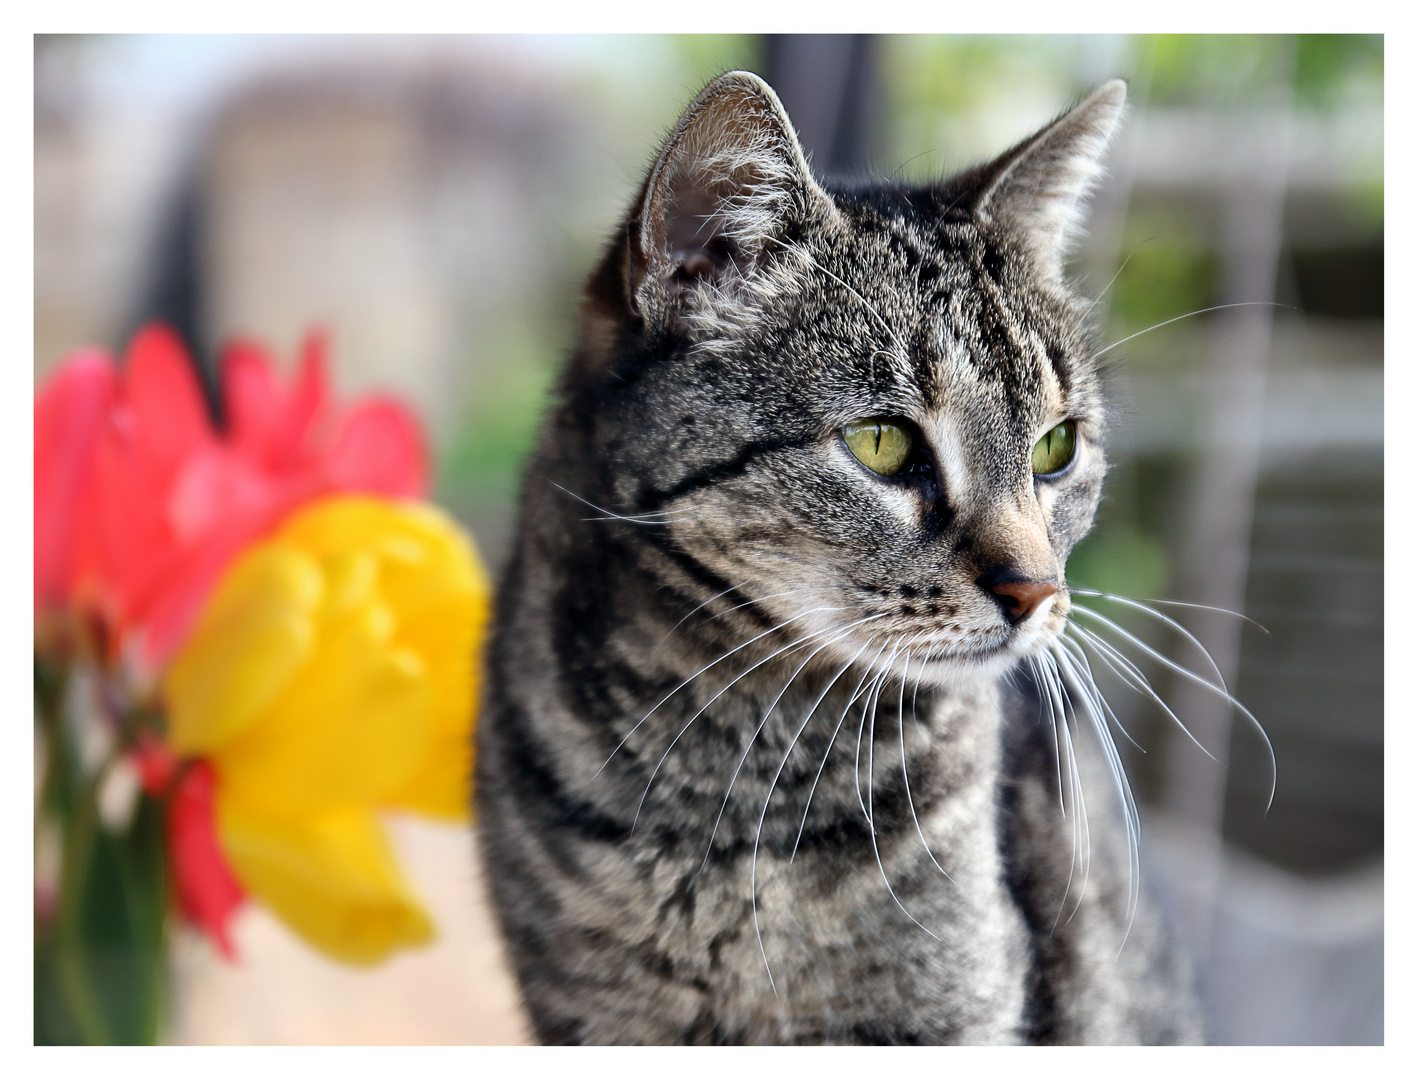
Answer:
(164, 543, 323, 755)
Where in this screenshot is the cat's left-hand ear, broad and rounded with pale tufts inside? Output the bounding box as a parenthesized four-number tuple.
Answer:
(627, 71, 827, 319)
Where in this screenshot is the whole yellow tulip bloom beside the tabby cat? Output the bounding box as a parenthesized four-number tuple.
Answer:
(163, 496, 491, 962)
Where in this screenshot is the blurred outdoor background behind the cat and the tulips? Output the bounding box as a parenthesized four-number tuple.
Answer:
(34, 35, 1384, 1043)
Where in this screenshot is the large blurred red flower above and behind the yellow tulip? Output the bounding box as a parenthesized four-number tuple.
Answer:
(35, 325, 427, 676)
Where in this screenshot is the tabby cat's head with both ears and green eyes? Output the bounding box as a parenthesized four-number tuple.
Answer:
(566, 72, 1124, 679)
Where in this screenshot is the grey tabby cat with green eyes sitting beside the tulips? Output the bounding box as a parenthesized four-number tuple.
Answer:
(476, 72, 1198, 1043)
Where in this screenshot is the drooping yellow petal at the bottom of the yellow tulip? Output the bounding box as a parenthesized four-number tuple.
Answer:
(217, 788, 434, 964)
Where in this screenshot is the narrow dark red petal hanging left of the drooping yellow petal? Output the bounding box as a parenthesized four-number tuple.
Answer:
(167, 761, 245, 960)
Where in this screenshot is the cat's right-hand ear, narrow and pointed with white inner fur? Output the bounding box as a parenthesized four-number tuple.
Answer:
(971, 79, 1127, 279)
